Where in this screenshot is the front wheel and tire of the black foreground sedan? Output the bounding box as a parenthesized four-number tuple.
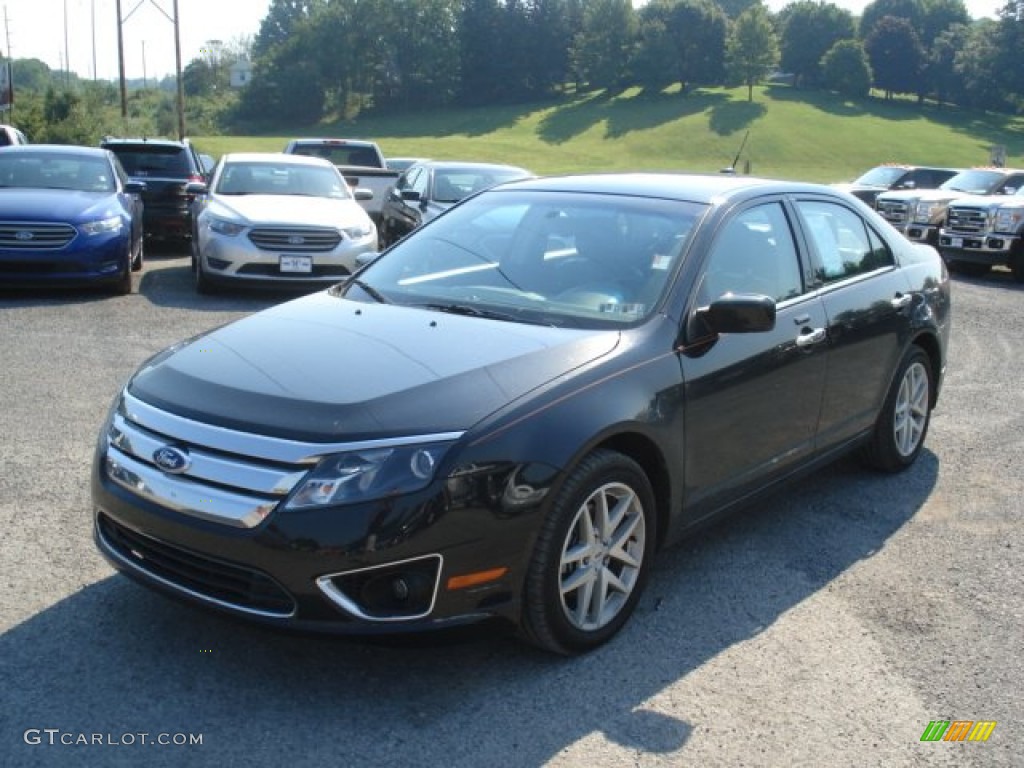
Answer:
(521, 451, 655, 655)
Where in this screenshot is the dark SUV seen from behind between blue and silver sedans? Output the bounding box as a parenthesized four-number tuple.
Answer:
(99, 136, 207, 242)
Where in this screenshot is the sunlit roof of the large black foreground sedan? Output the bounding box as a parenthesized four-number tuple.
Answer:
(501, 172, 831, 204)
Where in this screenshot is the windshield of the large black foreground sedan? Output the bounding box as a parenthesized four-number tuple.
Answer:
(340, 189, 705, 328)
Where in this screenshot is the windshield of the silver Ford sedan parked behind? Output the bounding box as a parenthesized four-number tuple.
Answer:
(213, 162, 352, 200)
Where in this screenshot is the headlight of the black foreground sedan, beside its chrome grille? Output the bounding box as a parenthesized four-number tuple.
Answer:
(285, 442, 452, 509)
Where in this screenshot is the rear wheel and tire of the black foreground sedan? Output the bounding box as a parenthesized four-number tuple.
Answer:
(863, 346, 934, 472)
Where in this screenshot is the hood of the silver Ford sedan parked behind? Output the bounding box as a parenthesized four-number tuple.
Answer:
(206, 195, 369, 227)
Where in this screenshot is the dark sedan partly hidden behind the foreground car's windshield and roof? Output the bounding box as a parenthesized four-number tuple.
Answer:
(379, 160, 534, 248)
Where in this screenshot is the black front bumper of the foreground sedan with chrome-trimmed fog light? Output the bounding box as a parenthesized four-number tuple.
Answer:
(92, 436, 542, 635)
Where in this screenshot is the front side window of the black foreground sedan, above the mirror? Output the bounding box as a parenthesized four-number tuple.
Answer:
(698, 203, 804, 304)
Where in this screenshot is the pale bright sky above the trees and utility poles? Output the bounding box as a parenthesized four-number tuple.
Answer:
(0, 0, 1006, 80)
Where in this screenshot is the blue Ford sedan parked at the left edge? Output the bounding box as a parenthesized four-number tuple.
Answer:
(0, 144, 145, 294)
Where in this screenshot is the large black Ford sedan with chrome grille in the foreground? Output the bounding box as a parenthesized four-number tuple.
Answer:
(92, 174, 950, 653)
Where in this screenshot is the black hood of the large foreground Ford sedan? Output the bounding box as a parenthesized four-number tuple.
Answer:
(128, 292, 620, 441)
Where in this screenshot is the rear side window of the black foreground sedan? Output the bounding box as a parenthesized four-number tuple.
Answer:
(797, 200, 894, 283)
